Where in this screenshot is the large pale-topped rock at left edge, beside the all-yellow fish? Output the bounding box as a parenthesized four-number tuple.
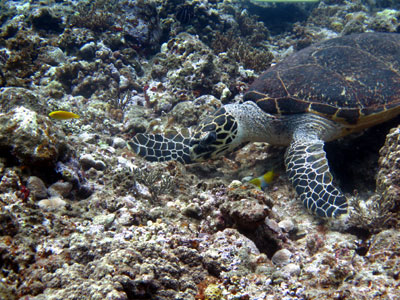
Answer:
(0, 106, 66, 166)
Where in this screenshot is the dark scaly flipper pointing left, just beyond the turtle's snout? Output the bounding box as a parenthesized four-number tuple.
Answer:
(128, 133, 191, 164)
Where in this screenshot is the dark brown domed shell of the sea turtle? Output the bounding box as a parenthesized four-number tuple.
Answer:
(244, 33, 400, 128)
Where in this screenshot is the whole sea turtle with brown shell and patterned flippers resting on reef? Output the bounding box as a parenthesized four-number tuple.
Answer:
(129, 33, 400, 217)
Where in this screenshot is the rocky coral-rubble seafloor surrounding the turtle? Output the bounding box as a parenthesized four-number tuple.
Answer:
(0, 0, 400, 300)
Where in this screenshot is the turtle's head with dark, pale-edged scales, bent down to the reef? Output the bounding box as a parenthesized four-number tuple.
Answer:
(190, 106, 243, 161)
